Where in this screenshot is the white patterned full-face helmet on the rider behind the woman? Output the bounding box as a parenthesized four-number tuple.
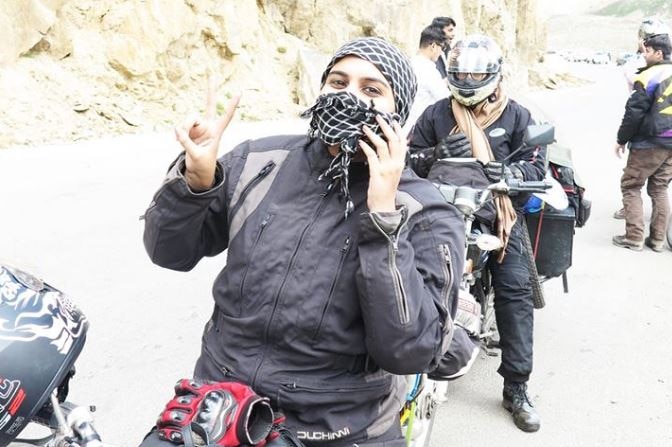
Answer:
(448, 34, 502, 106)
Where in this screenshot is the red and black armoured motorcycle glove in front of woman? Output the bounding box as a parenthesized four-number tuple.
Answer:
(156, 379, 274, 447)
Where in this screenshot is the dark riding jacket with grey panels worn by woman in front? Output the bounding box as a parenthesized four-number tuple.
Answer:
(144, 136, 464, 442)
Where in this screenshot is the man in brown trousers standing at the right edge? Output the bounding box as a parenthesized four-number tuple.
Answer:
(612, 34, 672, 252)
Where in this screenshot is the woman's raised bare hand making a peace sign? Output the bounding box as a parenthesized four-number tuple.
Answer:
(175, 79, 240, 191)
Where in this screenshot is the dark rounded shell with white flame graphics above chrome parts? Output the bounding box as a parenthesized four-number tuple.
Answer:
(0, 264, 88, 447)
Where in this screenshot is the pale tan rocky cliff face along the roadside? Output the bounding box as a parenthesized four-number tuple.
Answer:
(0, 0, 544, 147)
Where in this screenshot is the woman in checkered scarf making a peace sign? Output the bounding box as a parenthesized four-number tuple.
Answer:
(144, 38, 464, 447)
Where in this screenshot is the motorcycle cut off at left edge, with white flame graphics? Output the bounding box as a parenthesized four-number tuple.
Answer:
(0, 264, 105, 447)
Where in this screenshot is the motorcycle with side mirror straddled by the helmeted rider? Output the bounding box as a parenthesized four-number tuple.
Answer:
(401, 124, 568, 447)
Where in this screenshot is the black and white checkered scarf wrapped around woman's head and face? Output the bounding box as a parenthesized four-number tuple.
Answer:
(301, 37, 417, 218)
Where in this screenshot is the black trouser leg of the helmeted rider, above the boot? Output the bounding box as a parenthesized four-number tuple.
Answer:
(489, 215, 534, 382)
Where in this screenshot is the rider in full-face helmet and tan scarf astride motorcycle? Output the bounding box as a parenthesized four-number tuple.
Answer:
(410, 35, 545, 431)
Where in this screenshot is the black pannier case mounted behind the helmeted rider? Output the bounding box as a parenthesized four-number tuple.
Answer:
(526, 205, 576, 278)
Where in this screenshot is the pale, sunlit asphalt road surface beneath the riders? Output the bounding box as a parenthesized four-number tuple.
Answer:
(0, 66, 672, 447)
